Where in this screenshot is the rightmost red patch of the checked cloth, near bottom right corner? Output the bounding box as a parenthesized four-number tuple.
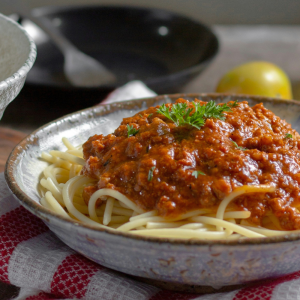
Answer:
(233, 271, 300, 300)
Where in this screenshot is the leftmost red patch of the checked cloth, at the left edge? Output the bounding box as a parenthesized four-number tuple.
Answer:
(0, 206, 49, 283)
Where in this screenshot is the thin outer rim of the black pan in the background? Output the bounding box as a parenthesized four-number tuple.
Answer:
(24, 4, 220, 90)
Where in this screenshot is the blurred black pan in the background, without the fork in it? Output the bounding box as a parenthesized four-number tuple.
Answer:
(22, 6, 218, 93)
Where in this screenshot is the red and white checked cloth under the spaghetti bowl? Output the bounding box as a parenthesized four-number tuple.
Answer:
(0, 83, 300, 300)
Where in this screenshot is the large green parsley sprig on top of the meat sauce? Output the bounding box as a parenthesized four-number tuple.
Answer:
(157, 101, 238, 129)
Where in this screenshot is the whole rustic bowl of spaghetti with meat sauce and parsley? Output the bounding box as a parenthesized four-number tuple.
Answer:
(6, 94, 300, 287)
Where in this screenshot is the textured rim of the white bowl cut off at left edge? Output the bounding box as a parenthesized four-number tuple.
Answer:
(0, 13, 37, 91)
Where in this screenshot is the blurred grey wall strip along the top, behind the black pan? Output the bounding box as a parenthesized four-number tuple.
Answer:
(0, 0, 300, 24)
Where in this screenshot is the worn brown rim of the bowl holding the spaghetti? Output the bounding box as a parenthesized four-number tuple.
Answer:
(4, 93, 300, 247)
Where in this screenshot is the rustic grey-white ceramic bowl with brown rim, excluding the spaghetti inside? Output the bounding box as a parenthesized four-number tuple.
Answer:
(5, 94, 300, 287)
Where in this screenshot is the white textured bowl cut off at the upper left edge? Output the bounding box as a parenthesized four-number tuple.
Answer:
(0, 14, 36, 119)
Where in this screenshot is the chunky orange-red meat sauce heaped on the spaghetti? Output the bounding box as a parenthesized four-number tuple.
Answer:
(82, 99, 300, 230)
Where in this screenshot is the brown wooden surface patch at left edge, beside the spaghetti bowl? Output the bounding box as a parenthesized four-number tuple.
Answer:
(0, 126, 27, 173)
